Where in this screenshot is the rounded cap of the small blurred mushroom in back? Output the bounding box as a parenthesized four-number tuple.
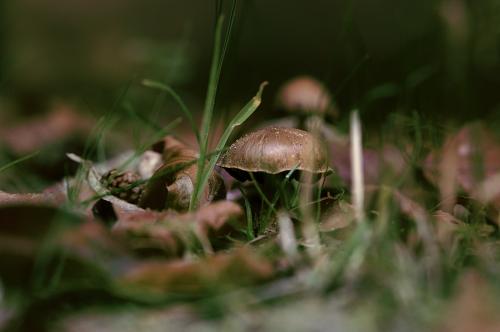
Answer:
(277, 76, 333, 114)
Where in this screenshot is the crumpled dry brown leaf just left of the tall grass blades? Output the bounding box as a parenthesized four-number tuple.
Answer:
(68, 136, 226, 213)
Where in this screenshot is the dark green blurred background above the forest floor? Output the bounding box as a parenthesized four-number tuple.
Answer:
(0, 0, 500, 189)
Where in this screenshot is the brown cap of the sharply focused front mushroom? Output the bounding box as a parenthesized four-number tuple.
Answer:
(218, 127, 331, 179)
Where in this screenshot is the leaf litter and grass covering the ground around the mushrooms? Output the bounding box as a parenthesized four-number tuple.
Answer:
(0, 102, 500, 331)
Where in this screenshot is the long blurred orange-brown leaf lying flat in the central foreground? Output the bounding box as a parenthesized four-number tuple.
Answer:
(117, 248, 274, 294)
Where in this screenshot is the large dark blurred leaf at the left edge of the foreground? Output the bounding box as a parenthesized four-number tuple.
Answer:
(0, 203, 126, 291)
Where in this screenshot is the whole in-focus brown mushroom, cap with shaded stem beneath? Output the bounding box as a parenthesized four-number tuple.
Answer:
(217, 127, 332, 235)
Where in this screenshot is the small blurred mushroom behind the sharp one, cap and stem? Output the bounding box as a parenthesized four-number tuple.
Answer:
(276, 76, 336, 131)
